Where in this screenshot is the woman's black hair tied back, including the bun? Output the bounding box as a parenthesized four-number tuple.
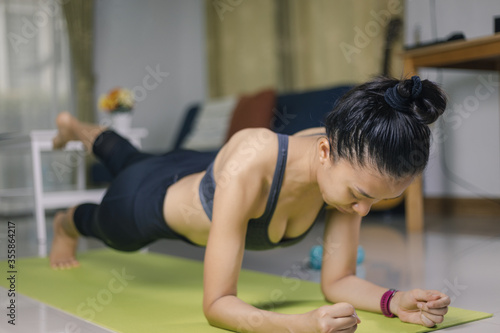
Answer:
(325, 77, 446, 179)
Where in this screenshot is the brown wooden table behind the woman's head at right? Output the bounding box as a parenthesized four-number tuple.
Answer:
(403, 34, 500, 231)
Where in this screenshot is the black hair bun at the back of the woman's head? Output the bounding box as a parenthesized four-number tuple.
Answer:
(395, 76, 447, 125)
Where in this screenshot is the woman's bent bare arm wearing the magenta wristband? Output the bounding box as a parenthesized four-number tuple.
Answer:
(321, 210, 450, 327)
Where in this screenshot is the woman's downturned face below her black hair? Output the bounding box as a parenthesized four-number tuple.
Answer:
(317, 140, 413, 216)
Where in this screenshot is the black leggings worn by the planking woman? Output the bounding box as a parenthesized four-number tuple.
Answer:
(73, 131, 215, 251)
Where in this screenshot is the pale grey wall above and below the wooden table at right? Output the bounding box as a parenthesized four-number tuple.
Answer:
(405, 0, 500, 198)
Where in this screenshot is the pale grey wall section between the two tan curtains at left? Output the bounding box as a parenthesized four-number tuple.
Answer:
(94, 0, 206, 151)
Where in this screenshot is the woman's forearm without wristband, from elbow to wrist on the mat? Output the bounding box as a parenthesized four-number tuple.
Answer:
(205, 296, 311, 333)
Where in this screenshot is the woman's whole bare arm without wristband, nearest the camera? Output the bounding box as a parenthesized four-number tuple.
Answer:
(203, 130, 357, 333)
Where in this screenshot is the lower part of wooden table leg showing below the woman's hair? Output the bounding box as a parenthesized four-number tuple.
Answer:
(405, 176, 424, 232)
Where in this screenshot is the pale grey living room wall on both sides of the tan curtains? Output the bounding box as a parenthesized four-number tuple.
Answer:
(95, 0, 500, 198)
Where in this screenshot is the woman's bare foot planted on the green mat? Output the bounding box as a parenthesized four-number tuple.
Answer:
(50, 212, 80, 269)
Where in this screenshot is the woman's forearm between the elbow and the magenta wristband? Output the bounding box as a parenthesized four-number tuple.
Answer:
(322, 275, 387, 313)
